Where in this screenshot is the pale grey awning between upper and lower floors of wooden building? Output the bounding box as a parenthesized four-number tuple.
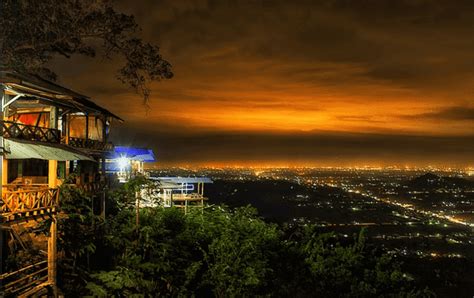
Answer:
(3, 139, 95, 161)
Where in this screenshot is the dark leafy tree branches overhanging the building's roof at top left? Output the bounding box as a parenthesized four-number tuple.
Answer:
(0, 0, 173, 103)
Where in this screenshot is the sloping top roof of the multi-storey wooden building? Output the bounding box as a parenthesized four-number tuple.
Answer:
(0, 69, 123, 121)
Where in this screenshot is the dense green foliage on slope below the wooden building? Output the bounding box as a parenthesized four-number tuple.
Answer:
(56, 180, 429, 297)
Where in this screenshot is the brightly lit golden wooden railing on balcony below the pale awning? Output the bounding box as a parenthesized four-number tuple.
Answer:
(0, 188, 59, 216)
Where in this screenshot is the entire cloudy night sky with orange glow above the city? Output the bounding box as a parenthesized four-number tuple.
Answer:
(54, 0, 474, 166)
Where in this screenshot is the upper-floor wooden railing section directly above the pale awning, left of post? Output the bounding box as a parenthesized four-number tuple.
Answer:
(2, 121, 61, 143)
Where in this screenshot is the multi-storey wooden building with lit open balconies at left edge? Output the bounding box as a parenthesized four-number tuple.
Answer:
(0, 70, 121, 296)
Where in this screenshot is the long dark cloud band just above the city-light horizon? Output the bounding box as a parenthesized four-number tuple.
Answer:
(110, 122, 474, 166)
